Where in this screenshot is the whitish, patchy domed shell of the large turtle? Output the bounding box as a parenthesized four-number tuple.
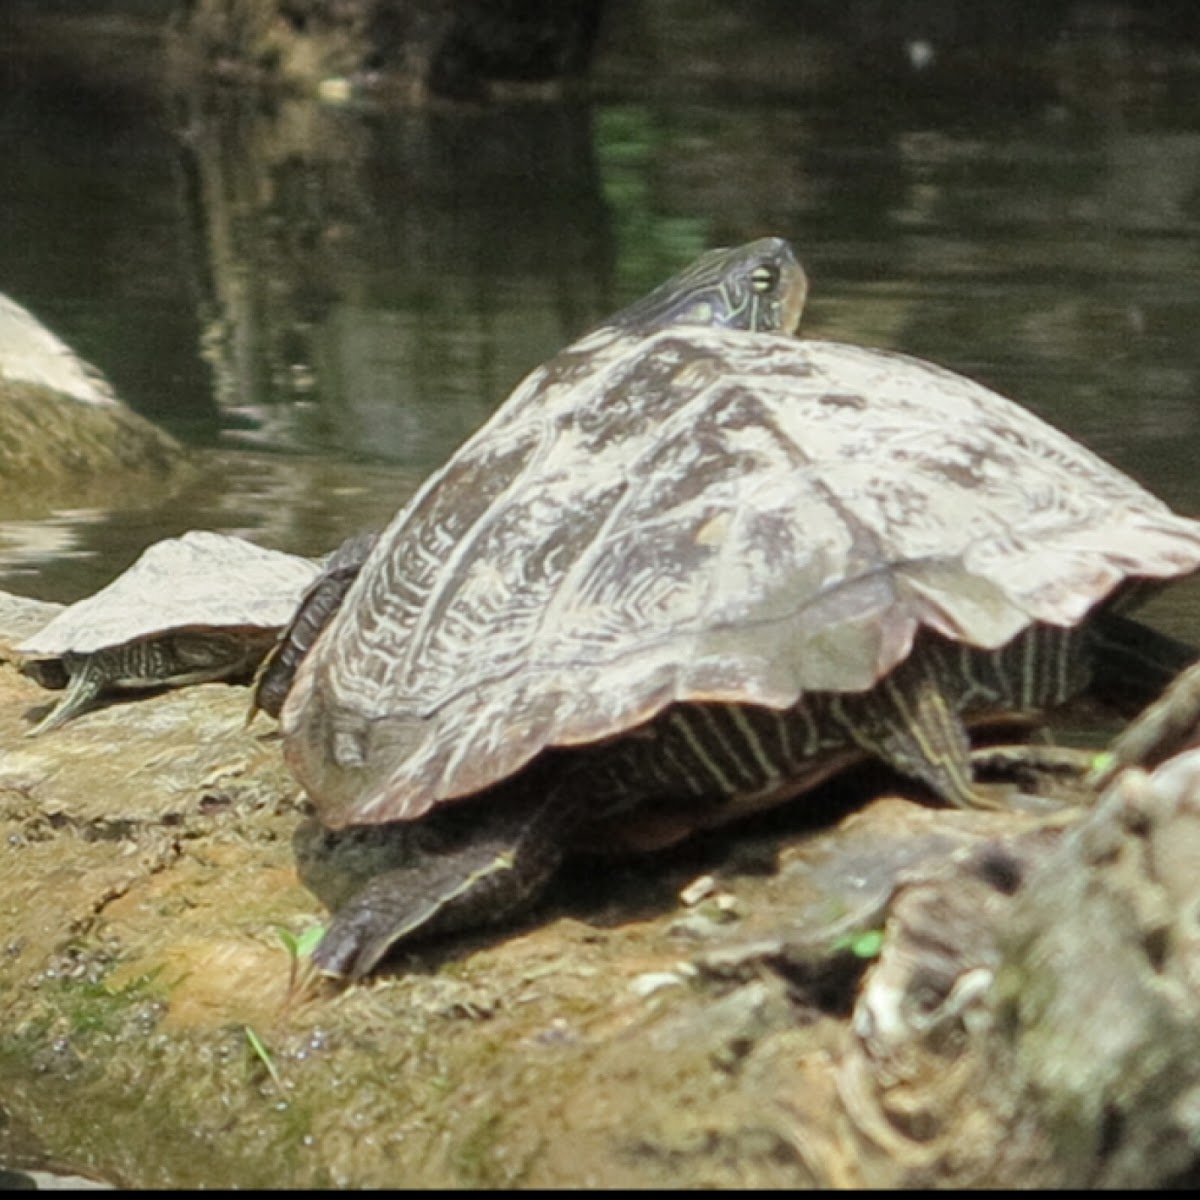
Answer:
(282, 326, 1200, 827)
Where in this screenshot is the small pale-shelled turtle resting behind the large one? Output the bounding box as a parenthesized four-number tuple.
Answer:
(17, 530, 319, 734)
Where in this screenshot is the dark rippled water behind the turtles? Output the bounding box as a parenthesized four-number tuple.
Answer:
(0, 4, 1200, 625)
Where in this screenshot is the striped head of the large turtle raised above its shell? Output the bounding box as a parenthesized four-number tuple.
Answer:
(605, 238, 809, 334)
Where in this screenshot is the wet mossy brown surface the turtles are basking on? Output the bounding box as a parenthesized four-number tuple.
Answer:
(0, 588, 1200, 1187)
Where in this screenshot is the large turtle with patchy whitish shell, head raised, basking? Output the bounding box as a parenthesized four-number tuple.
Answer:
(281, 239, 1200, 977)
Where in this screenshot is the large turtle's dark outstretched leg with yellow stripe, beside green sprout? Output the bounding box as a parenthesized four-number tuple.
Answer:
(313, 791, 563, 980)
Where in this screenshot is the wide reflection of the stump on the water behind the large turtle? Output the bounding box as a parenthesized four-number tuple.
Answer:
(188, 92, 612, 470)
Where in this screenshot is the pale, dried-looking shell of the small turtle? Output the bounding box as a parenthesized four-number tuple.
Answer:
(17, 530, 319, 658)
